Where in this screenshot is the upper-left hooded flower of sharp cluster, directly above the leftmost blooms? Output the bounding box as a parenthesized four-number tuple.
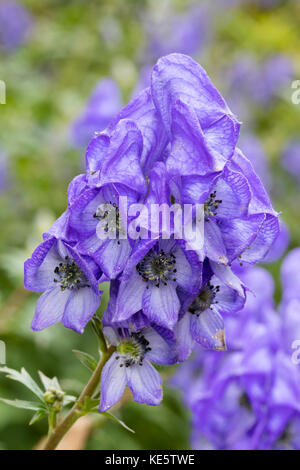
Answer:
(69, 120, 146, 279)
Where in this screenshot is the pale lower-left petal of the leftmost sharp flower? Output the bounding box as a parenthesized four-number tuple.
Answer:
(31, 287, 71, 331)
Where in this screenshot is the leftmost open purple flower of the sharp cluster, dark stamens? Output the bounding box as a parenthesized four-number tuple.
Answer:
(24, 237, 102, 333)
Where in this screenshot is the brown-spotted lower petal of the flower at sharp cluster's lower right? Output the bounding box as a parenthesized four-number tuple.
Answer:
(191, 309, 226, 351)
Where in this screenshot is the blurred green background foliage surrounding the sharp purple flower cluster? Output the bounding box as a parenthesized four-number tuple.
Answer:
(0, 0, 300, 449)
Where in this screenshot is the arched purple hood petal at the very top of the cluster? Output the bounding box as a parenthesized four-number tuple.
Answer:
(152, 54, 239, 157)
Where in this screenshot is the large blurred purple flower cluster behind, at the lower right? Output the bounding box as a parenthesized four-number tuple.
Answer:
(173, 248, 300, 450)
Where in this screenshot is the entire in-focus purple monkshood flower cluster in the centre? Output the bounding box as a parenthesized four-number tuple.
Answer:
(25, 54, 279, 411)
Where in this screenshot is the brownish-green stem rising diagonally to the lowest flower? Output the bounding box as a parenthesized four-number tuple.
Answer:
(43, 345, 115, 450)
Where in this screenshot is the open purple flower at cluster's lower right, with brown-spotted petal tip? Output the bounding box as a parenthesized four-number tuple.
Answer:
(174, 263, 245, 361)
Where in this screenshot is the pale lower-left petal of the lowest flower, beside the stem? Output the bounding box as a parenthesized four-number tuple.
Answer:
(99, 352, 127, 413)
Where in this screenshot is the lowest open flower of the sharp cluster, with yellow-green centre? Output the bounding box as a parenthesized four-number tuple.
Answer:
(99, 326, 176, 412)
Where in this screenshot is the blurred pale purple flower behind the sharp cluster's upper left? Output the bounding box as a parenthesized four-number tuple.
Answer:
(71, 78, 122, 148)
